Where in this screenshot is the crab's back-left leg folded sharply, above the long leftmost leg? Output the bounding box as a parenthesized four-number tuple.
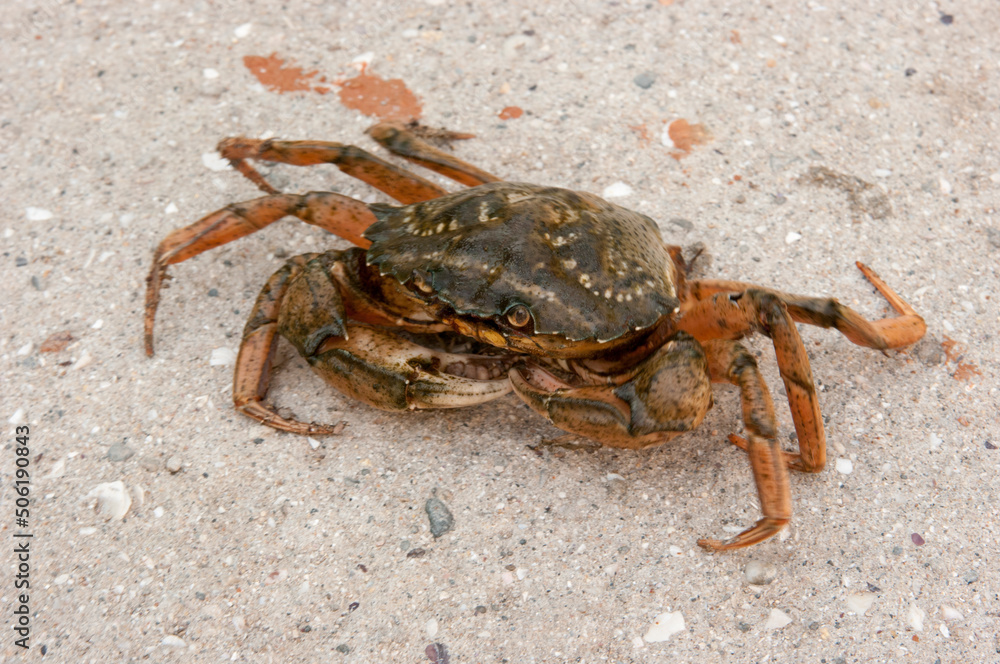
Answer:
(217, 137, 448, 204)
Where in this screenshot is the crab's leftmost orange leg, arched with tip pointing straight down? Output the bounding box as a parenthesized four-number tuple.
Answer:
(145, 192, 375, 356)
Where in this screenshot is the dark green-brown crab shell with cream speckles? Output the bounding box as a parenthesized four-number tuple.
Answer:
(365, 182, 678, 341)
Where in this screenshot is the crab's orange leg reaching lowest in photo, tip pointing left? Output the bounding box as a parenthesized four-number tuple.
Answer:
(698, 340, 792, 551)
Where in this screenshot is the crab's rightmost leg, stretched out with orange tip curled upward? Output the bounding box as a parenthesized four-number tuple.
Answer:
(688, 262, 927, 350)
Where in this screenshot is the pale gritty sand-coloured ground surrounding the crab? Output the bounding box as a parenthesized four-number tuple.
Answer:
(0, 0, 1000, 664)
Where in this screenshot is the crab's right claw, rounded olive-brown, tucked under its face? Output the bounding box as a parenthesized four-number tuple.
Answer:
(510, 332, 712, 449)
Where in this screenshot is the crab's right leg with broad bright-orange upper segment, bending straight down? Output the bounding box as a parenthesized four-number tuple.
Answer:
(677, 288, 826, 473)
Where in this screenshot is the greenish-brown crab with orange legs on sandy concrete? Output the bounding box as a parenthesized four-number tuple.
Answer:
(145, 123, 926, 550)
